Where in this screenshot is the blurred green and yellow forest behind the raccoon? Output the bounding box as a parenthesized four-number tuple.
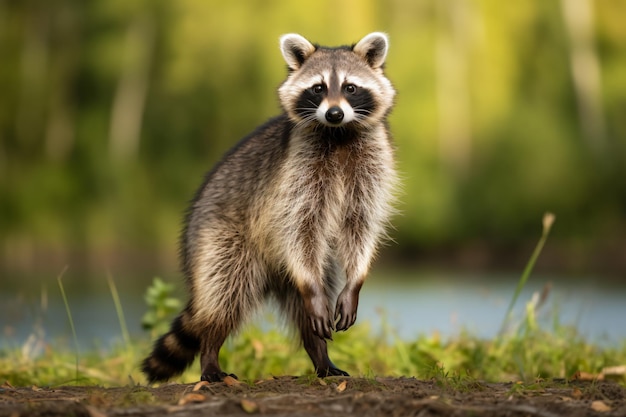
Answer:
(0, 0, 626, 279)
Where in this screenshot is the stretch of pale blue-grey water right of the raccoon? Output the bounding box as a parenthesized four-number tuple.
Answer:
(359, 274, 626, 345)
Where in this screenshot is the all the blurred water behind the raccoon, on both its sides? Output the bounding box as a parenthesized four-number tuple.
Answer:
(0, 272, 626, 349)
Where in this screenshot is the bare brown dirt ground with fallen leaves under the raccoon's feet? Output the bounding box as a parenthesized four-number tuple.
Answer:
(0, 377, 626, 417)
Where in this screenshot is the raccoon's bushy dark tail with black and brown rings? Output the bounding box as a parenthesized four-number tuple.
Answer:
(141, 309, 200, 383)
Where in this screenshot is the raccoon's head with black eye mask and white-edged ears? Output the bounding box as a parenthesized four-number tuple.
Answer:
(278, 32, 395, 128)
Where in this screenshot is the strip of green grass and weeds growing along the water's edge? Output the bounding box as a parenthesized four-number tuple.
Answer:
(0, 214, 626, 389)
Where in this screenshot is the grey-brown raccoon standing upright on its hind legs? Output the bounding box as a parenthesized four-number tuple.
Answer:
(142, 32, 397, 382)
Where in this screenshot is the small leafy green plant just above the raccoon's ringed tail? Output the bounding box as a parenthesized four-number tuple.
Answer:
(141, 277, 182, 338)
